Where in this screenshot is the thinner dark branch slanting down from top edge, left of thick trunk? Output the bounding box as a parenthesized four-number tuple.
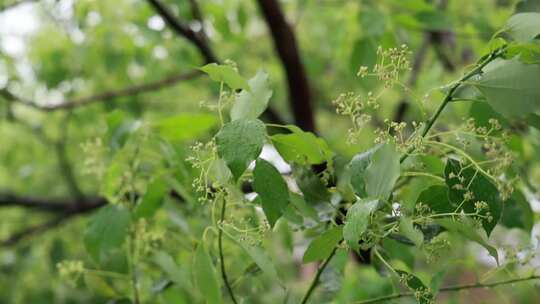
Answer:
(147, 0, 218, 63)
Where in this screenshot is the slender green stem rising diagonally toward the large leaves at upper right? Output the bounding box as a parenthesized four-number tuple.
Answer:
(399, 47, 505, 163)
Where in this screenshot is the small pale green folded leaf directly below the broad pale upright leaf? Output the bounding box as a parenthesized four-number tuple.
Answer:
(343, 200, 379, 251)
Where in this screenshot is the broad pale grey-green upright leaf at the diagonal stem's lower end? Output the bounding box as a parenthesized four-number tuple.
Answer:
(364, 143, 400, 199)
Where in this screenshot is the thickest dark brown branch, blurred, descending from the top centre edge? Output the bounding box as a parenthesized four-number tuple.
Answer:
(257, 0, 315, 131)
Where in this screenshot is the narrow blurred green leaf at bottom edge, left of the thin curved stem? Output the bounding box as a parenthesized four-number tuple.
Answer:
(193, 243, 222, 304)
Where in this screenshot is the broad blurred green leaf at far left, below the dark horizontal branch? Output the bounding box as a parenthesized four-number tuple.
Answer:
(84, 205, 130, 262)
